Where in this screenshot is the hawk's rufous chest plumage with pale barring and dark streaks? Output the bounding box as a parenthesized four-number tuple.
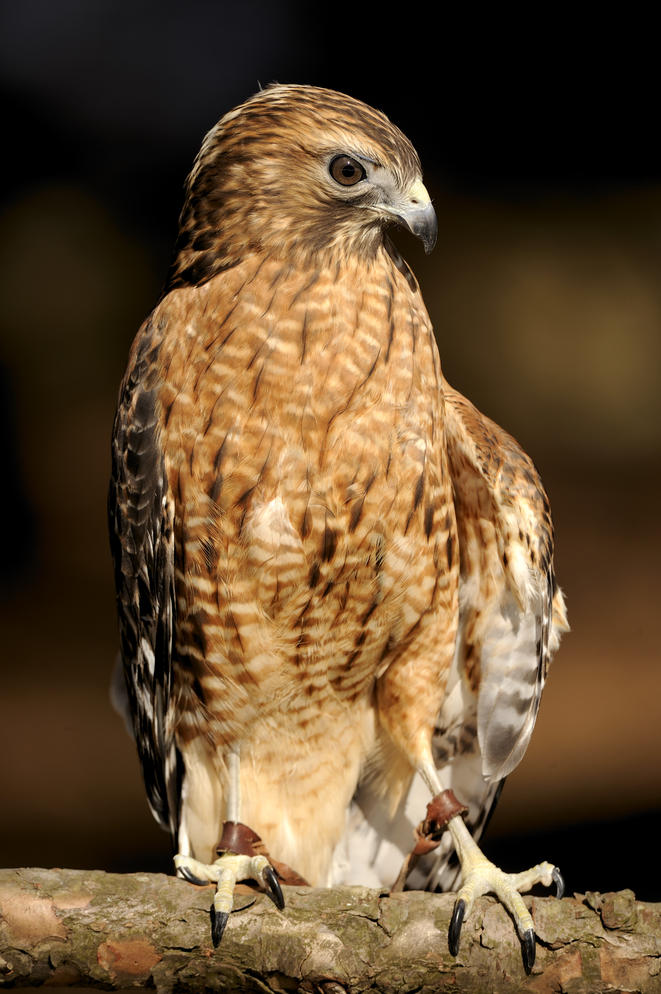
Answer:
(139, 250, 450, 739)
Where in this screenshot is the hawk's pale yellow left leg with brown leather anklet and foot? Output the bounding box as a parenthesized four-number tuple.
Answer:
(174, 749, 285, 946)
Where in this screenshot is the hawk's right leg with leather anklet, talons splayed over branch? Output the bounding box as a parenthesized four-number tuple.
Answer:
(421, 763, 564, 973)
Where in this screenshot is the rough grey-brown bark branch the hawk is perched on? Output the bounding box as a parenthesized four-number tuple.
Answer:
(0, 869, 661, 994)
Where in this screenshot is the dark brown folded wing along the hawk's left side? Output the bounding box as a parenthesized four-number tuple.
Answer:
(108, 323, 181, 834)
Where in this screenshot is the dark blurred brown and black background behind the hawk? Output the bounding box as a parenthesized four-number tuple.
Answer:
(0, 0, 661, 900)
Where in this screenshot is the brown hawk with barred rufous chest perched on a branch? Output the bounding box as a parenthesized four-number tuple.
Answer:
(109, 85, 566, 969)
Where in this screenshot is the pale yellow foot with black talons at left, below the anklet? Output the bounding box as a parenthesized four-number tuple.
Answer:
(174, 852, 285, 946)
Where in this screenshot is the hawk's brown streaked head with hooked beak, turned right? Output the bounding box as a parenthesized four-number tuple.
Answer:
(169, 85, 436, 288)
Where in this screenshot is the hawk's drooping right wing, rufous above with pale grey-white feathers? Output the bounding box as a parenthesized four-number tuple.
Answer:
(444, 385, 567, 782)
